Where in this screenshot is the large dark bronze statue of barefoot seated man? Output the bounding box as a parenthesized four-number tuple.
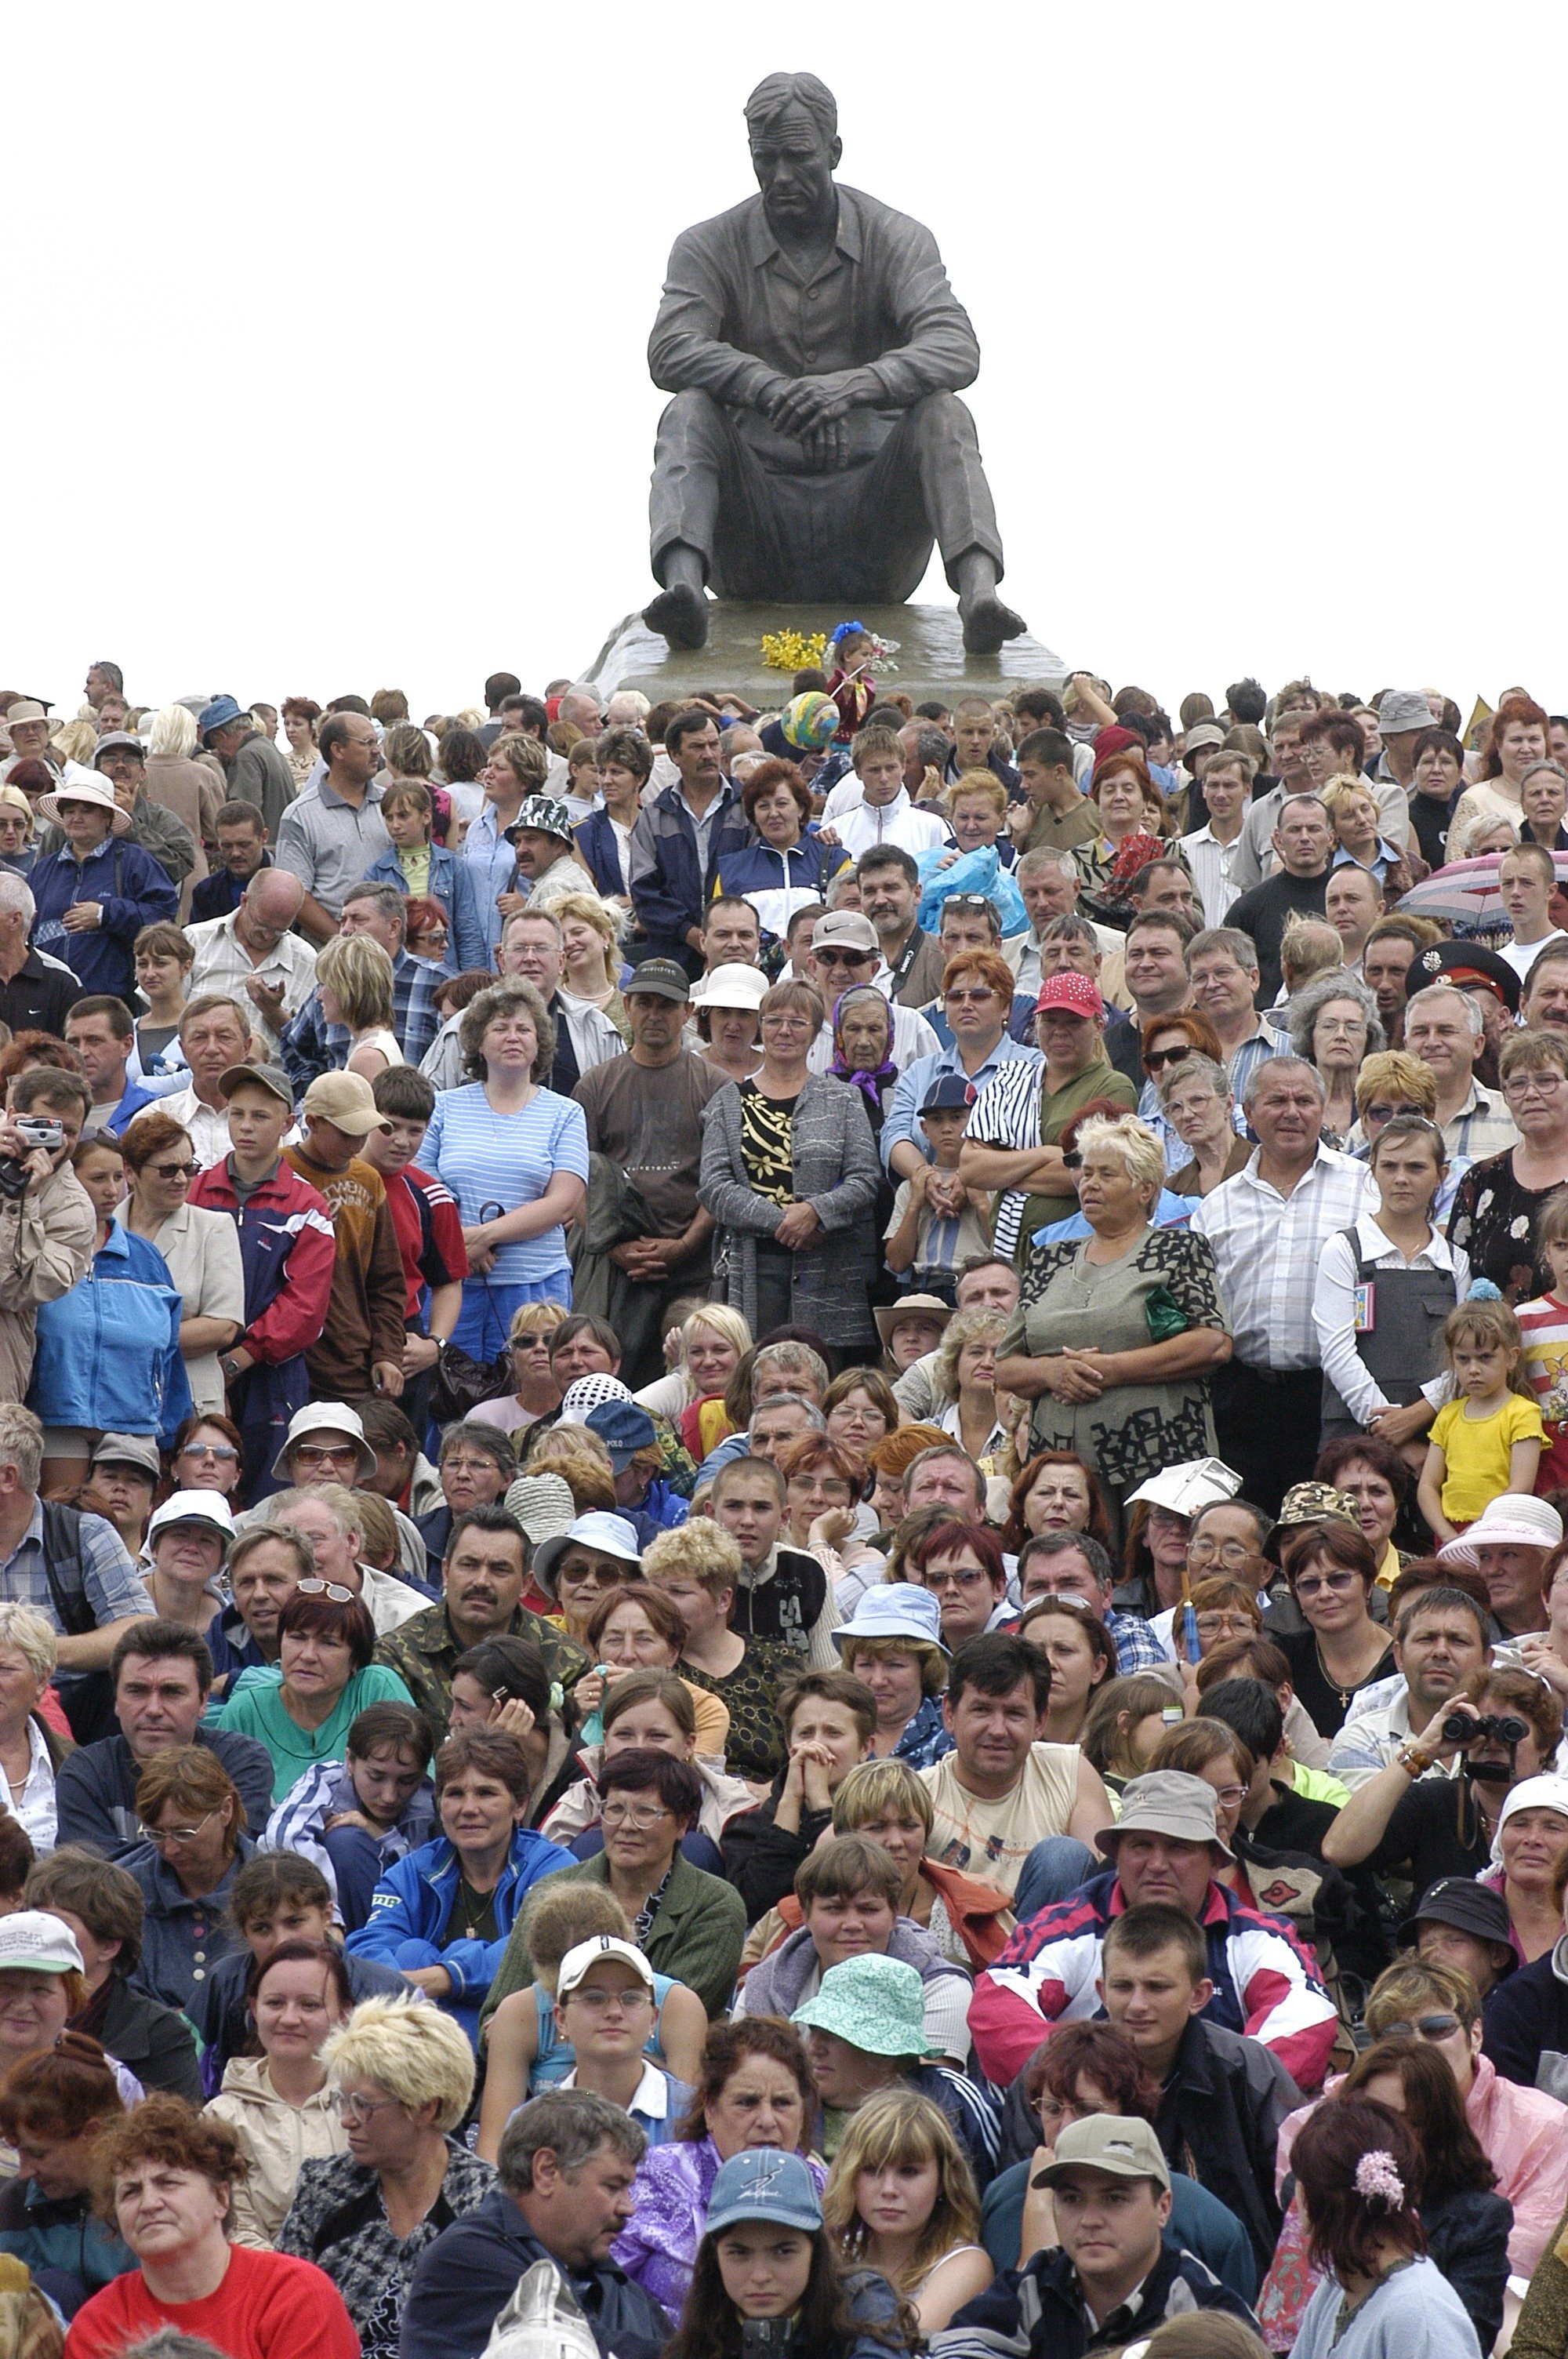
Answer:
(644, 73, 1023, 653)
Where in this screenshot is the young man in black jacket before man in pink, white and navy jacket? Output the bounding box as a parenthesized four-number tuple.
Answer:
(1102, 1901, 1301, 2274)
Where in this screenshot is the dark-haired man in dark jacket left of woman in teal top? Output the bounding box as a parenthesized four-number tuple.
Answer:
(54, 1618, 274, 1859)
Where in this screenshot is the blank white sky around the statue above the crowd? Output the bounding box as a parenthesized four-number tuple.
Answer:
(0, 0, 1568, 714)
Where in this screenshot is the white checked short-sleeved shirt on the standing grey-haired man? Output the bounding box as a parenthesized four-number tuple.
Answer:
(1193, 1147, 1377, 1376)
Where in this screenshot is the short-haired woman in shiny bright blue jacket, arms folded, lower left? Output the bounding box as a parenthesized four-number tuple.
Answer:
(347, 1729, 572, 2037)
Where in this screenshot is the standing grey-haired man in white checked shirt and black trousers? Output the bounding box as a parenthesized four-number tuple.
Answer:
(1193, 1057, 1374, 1514)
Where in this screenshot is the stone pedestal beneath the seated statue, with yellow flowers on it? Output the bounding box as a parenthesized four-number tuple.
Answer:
(585, 602, 1065, 710)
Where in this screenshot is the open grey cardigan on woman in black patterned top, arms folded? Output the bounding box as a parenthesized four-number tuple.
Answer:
(698, 1074, 880, 1345)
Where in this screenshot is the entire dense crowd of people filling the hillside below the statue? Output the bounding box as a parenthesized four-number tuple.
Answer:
(0, 651, 1568, 2359)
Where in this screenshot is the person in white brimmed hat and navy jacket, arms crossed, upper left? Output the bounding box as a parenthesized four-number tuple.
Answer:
(28, 762, 180, 1000)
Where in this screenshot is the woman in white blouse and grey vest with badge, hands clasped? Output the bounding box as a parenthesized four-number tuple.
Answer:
(1311, 1114, 1469, 1456)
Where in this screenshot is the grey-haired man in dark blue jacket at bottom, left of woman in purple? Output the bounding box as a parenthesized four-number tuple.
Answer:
(398, 2088, 672, 2359)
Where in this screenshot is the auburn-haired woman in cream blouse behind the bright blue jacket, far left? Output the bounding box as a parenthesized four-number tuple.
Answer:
(115, 1107, 245, 1411)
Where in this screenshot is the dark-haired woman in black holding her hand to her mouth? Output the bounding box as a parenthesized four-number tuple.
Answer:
(719, 1670, 877, 1925)
